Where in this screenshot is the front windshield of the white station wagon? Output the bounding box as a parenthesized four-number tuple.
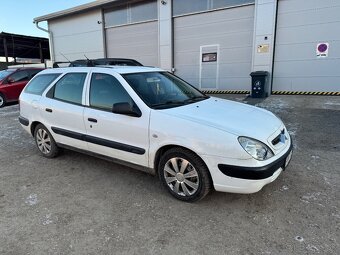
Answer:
(123, 72, 209, 109)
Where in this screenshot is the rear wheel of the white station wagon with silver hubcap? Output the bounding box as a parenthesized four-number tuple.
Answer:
(34, 124, 59, 158)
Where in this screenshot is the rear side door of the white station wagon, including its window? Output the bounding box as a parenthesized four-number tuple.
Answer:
(41, 72, 87, 150)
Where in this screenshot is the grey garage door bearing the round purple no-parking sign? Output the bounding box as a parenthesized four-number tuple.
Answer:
(273, 0, 340, 92)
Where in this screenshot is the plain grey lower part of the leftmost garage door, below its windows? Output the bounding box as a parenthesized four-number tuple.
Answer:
(106, 21, 159, 66)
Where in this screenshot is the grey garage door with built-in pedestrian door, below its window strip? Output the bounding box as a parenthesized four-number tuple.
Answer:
(174, 1, 254, 90)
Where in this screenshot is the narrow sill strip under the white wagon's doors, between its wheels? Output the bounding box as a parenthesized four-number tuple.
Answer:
(57, 143, 156, 175)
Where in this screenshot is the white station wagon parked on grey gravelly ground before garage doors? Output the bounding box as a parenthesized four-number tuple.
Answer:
(19, 66, 292, 202)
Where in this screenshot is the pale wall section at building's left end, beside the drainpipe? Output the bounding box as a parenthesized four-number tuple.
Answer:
(48, 9, 104, 61)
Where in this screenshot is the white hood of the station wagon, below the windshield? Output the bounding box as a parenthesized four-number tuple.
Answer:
(163, 97, 283, 143)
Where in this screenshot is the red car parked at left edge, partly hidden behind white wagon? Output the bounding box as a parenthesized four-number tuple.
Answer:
(0, 67, 44, 108)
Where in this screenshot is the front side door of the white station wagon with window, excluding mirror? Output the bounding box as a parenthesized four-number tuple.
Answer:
(84, 72, 150, 166)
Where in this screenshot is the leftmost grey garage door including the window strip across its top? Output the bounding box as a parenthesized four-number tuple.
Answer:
(104, 0, 159, 66)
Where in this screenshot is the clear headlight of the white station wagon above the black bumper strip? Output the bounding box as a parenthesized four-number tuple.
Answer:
(238, 136, 274, 160)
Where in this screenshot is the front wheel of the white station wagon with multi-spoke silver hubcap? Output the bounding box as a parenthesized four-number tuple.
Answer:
(158, 148, 212, 202)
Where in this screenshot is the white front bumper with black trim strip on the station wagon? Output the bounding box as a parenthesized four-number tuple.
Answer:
(203, 139, 293, 194)
